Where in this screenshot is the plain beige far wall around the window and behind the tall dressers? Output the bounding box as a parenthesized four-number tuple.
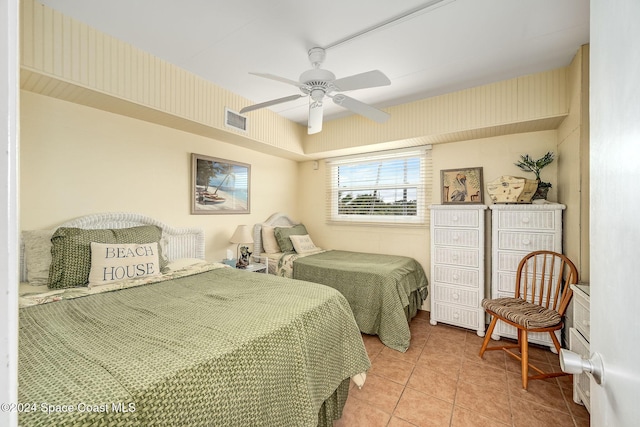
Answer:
(297, 131, 558, 309)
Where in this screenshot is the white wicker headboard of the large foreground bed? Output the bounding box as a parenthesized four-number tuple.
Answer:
(20, 212, 204, 282)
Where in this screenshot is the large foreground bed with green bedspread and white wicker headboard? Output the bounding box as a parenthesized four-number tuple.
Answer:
(18, 213, 370, 427)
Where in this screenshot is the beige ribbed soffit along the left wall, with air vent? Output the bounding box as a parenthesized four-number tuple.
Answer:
(20, 0, 305, 158)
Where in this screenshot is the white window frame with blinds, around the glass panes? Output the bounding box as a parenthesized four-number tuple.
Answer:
(327, 145, 432, 225)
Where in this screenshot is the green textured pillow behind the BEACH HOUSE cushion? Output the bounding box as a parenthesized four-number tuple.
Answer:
(48, 225, 167, 289)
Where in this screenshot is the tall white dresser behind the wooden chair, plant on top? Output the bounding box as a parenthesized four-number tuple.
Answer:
(489, 203, 565, 353)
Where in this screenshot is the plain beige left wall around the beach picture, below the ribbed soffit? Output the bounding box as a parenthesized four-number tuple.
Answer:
(20, 91, 298, 261)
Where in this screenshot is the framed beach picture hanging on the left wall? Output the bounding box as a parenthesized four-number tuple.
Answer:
(191, 154, 251, 214)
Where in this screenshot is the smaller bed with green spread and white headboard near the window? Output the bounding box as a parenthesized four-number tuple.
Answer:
(253, 213, 427, 352)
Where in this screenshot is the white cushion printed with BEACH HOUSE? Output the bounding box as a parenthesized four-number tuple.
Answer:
(89, 242, 160, 285)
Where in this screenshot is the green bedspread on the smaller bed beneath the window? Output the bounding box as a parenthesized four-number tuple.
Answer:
(293, 250, 427, 352)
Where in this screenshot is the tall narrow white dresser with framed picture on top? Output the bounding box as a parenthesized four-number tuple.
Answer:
(430, 205, 487, 337)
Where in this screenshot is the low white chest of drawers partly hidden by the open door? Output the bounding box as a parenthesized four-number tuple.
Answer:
(569, 283, 591, 412)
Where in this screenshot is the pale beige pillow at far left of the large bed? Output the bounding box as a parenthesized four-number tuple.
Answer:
(22, 230, 55, 286)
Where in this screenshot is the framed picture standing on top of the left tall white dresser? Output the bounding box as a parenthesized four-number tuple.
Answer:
(440, 167, 484, 205)
